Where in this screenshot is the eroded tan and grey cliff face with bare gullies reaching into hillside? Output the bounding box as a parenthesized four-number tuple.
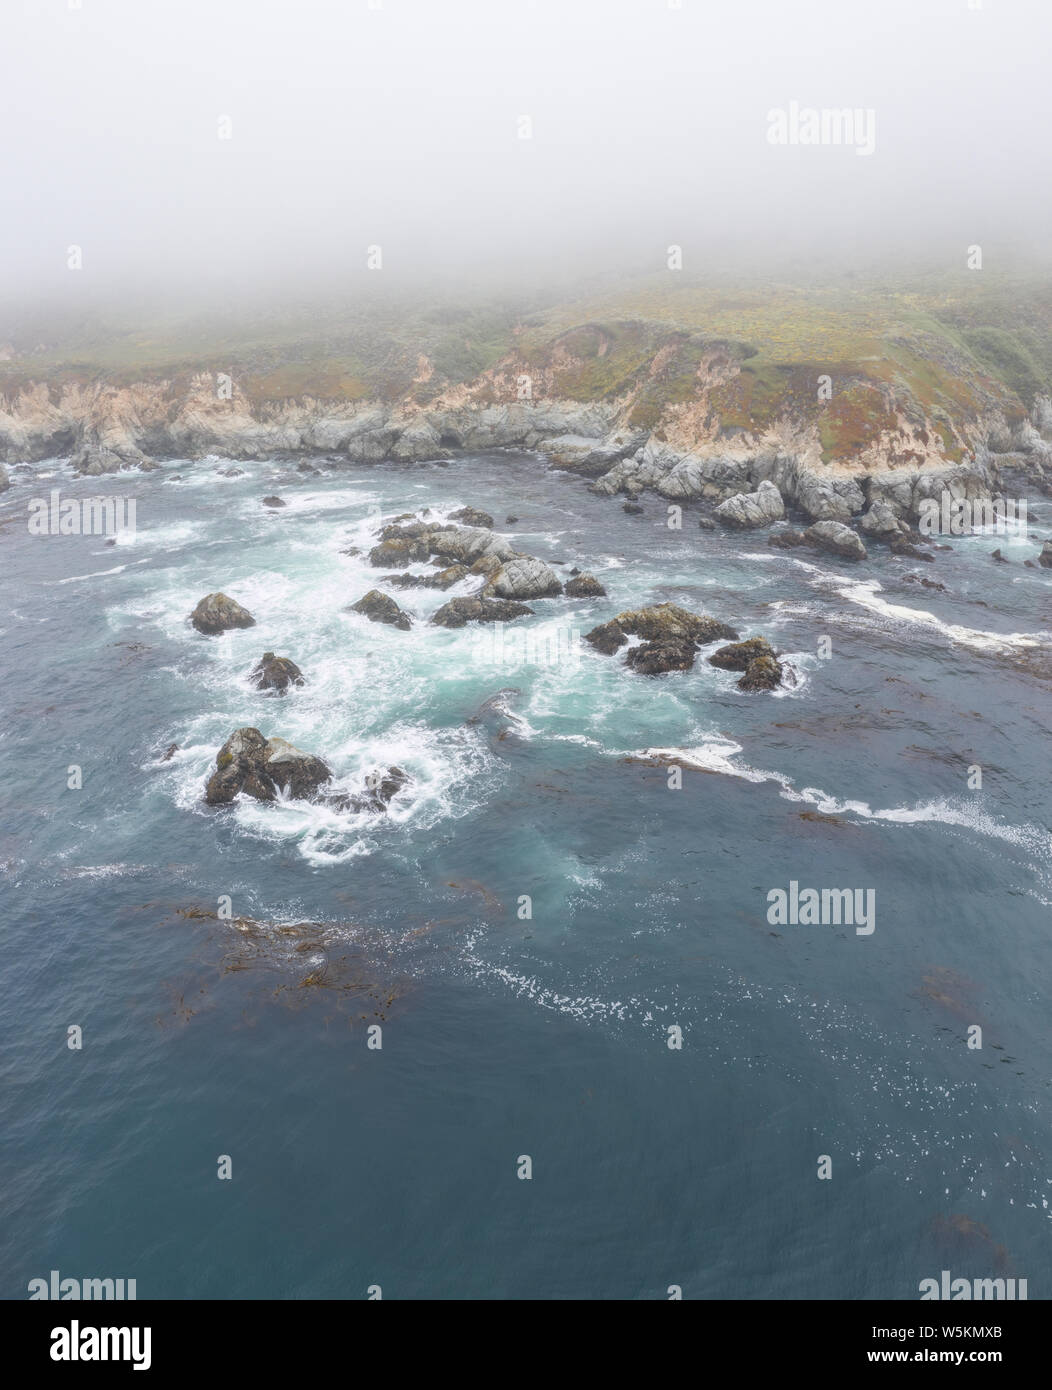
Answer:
(0, 349, 1052, 521)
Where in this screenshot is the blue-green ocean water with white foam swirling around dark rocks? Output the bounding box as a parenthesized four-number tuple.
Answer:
(0, 452, 1052, 1300)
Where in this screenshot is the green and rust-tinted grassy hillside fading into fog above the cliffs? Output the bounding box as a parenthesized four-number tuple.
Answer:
(0, 271, 1052, 459)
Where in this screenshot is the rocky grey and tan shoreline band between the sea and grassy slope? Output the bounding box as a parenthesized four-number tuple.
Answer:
(0, 374, 1052, 537)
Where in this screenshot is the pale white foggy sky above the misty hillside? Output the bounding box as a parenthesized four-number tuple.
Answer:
(0, 0, 1052, 314)
